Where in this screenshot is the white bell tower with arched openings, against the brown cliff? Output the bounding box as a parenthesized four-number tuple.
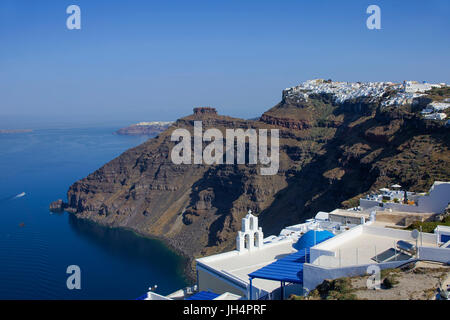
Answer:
(236, 210, 264, 252)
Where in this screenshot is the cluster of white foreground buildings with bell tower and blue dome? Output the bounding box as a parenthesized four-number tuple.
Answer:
(139, 182, 450, 300)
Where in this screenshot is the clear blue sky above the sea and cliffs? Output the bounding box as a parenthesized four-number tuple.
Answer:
(0, 0, 450, 127)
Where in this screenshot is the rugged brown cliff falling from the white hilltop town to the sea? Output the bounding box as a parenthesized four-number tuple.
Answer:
(68, 88, 450, 280)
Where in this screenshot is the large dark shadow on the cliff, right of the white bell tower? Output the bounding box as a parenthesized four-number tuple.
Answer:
(259, 104, 440, 235)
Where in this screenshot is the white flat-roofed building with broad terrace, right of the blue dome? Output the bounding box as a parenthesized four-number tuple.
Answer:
(303, 223, 450, 290)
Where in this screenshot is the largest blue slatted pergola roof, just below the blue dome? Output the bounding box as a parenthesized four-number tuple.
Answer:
(248, 249, 309, 284)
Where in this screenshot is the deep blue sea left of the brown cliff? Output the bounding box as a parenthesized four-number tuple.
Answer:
(0, 127, 187, 299)
